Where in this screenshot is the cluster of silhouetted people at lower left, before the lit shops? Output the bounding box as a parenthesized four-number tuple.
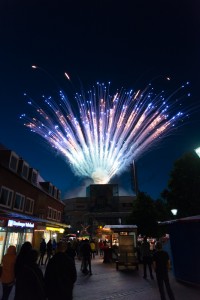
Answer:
(1, 239, 77, 300)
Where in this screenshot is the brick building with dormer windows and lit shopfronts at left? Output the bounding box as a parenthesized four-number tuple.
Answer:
(0, 145, 69, 261)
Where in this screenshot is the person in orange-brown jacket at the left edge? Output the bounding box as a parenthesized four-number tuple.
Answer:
(1, 246, 16, 300)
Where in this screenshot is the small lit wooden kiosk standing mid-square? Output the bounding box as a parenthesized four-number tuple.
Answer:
(104, 225, 139, 270)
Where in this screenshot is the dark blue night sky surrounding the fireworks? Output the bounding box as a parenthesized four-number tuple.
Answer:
(0, 0, 200, 198)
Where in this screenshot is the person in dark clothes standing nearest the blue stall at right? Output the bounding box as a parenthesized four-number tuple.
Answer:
(153, 242, 175, 300)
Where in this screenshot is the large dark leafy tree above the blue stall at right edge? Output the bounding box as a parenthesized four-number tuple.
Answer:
(161, 152, 200, 217)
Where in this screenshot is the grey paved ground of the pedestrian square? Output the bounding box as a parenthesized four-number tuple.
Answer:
(0, 257, 200, 300)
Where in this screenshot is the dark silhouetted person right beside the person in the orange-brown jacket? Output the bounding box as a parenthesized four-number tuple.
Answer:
(14, 249, 46, 300)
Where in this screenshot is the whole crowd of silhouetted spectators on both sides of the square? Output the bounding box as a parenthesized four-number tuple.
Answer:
(1, 237, 175, 300)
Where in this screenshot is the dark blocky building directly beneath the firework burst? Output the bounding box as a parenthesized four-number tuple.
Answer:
(63, 184, 135, 235)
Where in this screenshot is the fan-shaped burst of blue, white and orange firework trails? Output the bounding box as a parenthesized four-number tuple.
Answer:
(21, 83, 188, 184)
